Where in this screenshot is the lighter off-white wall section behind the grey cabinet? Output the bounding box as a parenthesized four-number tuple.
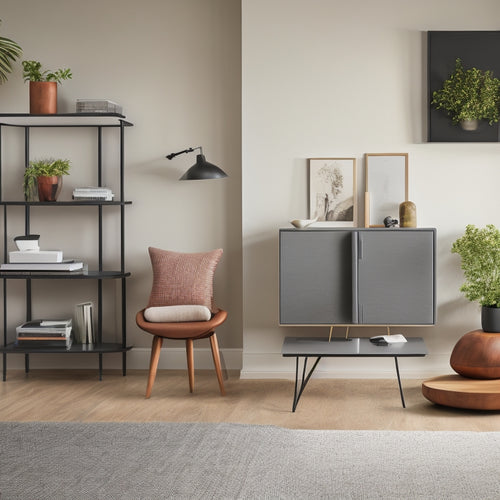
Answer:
(242, 0, 500, 377)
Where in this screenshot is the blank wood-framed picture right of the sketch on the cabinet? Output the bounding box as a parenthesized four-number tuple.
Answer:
(365, 153, 408, 227)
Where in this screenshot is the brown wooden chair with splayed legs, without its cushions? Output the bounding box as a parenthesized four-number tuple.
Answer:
(136, 309, 227, 398)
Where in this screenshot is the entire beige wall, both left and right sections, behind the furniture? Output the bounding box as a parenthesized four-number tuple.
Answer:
(0, 0, 500, 377)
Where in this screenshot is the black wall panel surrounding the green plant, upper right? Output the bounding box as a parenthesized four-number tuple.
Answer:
(427, 31, 500, 142)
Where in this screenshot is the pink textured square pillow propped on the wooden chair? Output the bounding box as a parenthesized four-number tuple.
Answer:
(148, 247, 222, 312)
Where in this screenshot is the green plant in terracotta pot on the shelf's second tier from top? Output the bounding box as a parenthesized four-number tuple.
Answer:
(23, 158, 71, 201)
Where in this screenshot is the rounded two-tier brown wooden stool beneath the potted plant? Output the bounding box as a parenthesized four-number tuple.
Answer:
(422, 330, 500, 410)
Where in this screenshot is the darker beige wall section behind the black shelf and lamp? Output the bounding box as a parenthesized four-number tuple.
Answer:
(0, 0, 242, 368)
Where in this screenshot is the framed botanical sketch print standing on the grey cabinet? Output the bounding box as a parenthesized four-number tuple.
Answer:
(309, 158, 357, 227)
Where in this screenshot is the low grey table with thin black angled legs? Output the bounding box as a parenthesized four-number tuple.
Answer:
(281, 337, 427, 412)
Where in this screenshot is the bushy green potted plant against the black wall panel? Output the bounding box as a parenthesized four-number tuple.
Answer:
(431, 58, 500, 130)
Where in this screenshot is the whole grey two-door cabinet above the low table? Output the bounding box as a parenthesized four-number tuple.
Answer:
(279, 228, 436, 325)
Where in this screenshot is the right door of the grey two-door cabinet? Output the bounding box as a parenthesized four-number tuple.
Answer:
(358, 229, 435, 325)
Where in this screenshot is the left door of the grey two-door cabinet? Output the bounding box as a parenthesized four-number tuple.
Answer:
(280, 229, 353, 325)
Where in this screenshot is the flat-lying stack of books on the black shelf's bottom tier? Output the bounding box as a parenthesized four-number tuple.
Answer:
(16, 318, 73, 349)
